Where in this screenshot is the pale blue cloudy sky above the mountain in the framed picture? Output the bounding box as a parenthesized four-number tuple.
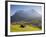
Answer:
(10, 5, 42, 16)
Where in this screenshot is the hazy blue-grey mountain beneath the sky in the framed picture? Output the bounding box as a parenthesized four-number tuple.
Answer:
(11, 9, 41, 22)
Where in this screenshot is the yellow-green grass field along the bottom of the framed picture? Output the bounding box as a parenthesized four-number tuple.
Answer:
(10, 24, 41, 32)
